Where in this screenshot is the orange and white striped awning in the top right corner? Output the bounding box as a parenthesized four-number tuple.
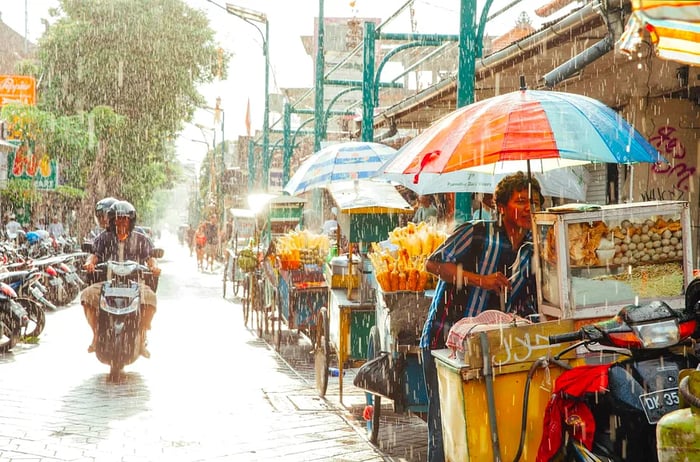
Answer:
(617, 0, 700, 66)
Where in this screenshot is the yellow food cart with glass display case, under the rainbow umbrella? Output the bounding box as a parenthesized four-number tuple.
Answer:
(432, 201, 693, 461)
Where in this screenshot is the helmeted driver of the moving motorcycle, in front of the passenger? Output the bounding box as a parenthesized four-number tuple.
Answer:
(81, 201, 160, 358)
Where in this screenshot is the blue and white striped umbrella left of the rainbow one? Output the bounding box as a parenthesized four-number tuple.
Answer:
(284, 141, 396, 196)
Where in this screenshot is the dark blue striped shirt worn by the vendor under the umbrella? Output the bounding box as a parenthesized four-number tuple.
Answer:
(420, 221, 537, 349)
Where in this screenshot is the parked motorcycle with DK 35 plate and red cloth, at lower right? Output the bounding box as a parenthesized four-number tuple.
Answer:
(537, 294, 700, 462)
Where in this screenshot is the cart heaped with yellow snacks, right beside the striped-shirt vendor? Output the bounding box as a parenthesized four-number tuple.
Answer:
(355, 222, 447, 444)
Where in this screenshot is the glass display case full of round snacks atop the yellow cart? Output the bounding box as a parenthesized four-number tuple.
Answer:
(533, 201, 693, 319)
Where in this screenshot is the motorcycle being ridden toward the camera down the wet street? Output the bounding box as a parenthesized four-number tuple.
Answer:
(88, 249, 163, 377)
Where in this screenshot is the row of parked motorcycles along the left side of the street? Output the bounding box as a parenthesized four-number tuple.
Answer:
(0, 239, 88, 353)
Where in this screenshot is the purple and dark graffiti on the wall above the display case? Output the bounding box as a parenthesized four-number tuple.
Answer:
(642, 125, 697, 201)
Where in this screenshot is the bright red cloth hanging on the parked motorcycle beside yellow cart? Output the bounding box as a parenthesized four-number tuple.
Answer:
(535, 364, 610, 462)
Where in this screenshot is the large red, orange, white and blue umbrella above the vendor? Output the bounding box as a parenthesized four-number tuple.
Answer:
(378, 90, 666, 185)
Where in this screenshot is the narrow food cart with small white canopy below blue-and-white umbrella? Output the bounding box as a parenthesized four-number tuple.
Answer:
(314, 180, 413, 402)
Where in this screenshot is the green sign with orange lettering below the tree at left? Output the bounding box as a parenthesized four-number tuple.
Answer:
(7, 144, 58, 189)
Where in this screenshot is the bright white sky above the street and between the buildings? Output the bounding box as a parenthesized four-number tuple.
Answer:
(0, 0, 568, 161)
